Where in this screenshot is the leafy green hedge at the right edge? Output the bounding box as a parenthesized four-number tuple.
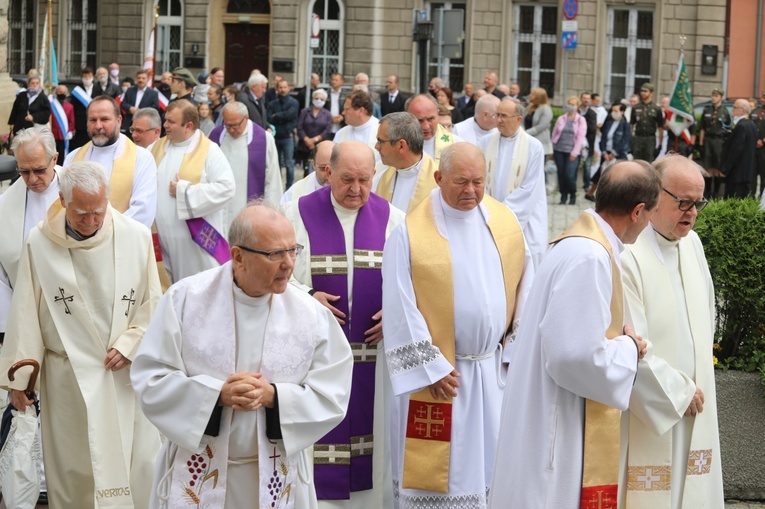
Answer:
(694, 198, 765, 381)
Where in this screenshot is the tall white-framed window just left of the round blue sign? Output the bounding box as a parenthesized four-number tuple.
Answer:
(513, 5, 558, 98)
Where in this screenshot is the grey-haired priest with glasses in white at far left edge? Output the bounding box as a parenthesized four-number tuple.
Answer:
(0, 127, 61, 342)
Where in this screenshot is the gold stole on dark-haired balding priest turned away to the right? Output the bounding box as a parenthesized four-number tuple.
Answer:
(550, 213, 624, 500)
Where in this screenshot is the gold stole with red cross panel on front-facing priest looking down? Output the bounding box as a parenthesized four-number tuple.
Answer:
(402, 195, 526, 493)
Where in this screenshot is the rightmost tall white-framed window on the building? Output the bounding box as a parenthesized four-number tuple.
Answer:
(604, 7, 653, 103)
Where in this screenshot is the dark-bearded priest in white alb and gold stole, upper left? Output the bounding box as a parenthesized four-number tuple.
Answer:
(64, 95, 157, 228)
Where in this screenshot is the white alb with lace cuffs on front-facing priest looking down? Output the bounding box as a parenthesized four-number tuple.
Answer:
(383, 189, 533, 509)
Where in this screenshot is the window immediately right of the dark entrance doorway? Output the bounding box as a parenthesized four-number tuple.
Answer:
(308, 0, 345, 83)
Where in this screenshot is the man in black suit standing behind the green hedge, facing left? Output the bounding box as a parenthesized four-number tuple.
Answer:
(720, 99, 757, 198)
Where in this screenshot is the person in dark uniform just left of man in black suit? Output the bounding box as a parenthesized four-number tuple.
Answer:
(699, 88, 731, 198)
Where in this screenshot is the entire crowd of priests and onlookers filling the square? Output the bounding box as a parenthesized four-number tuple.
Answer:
(0, 64, 748, 509)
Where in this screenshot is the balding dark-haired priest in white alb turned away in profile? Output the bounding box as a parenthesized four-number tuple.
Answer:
(489, 161, 661, 509)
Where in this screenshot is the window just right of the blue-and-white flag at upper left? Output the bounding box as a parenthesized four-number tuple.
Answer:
(66, 0, 98, 76)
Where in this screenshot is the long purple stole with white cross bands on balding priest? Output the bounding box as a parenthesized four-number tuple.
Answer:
(298, 186, 390, 500)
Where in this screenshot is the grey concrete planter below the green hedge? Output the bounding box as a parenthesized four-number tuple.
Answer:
(715, 370, 765, 501)
